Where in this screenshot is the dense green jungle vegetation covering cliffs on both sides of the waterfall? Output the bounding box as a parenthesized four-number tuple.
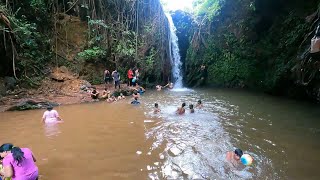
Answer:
(0, 0, 320, 101)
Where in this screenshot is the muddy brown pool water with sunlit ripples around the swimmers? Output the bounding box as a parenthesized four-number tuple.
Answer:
(0, 89, 320, 180)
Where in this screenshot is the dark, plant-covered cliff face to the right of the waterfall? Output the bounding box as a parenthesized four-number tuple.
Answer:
(176, 0, 320, 100)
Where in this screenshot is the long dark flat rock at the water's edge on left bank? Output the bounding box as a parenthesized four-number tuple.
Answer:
(7, 100, 59, 111)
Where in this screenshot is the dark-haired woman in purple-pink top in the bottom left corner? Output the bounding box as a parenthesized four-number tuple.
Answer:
(0, 144, 39, 180)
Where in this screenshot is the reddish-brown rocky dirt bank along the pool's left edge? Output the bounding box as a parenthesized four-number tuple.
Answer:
(0, 80, 129, 112)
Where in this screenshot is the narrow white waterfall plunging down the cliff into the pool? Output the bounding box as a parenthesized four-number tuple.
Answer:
(166, 13, 183, 88)
